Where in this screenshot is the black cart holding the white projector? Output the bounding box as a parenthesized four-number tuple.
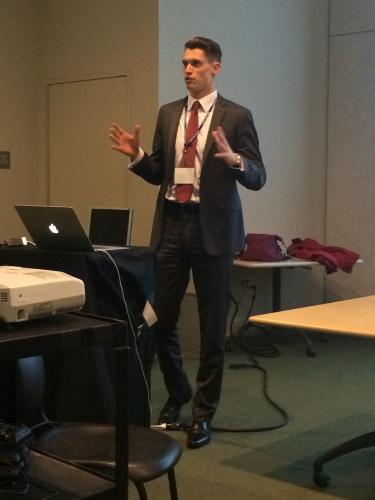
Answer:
(0, 313, 128, 500)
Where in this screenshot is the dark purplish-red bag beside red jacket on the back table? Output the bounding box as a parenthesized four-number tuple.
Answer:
(238, 233, 288, 262)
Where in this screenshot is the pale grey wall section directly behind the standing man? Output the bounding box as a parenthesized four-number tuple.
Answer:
(159, 0, 328, 318)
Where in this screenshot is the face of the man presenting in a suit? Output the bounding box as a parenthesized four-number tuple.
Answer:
(182, 49, 220, 99)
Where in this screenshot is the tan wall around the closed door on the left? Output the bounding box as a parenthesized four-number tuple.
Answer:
(0, 0, 158, 244)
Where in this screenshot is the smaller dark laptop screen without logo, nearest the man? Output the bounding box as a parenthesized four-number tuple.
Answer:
(89, 208, 133, 246)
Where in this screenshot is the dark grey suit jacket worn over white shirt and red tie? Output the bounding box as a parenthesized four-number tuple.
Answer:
(132, 95, 266, 255)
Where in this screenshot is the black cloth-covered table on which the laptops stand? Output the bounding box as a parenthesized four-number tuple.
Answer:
(0, 246, 154, 425)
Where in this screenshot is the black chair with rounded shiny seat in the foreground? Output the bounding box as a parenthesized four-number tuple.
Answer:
(17, 356, 182, 500)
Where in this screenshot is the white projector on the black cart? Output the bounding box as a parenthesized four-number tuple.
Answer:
(0, 266, 85, 323)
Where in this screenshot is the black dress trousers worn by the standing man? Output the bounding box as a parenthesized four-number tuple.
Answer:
(154, 207, 233, 420)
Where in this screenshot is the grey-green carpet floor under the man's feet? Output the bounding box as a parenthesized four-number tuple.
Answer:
(129, 331, 375, 500)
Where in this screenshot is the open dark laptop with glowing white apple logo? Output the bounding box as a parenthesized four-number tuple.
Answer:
(15, 205, 94, 252)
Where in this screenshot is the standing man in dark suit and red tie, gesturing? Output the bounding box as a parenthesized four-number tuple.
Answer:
(110, 37, 266, 448)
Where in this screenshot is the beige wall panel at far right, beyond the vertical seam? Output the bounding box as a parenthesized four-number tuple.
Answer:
(326, 0, 375, 300)
